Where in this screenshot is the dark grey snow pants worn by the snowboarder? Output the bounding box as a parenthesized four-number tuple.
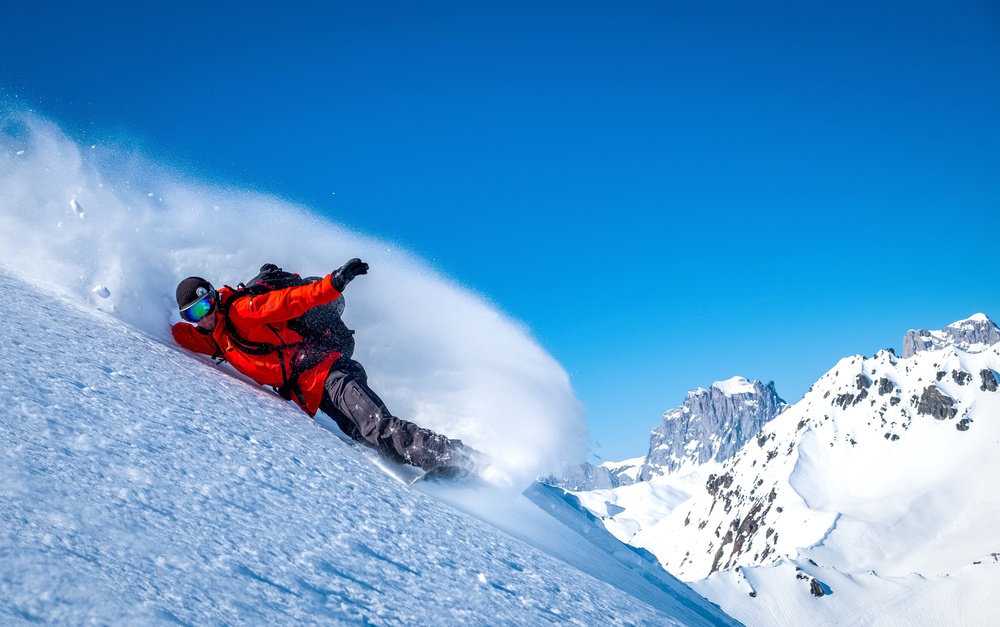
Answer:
(319, 358, 454, 470)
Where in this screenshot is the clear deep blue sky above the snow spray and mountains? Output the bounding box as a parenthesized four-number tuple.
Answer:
(0, 0, 1000, 459)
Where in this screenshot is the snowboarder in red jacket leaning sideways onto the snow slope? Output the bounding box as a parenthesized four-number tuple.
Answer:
(171, 258, 481, 474)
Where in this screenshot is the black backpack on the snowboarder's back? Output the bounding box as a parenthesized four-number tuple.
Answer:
(236, 263, 354, 359)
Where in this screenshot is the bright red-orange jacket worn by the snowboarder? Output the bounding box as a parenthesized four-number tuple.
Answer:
(171, 275, 340, 416)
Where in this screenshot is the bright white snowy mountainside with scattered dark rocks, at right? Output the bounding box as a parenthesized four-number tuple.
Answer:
(581, 314, 1000, 625)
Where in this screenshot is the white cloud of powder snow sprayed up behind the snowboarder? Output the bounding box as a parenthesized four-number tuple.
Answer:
(0, 111, 586, 487)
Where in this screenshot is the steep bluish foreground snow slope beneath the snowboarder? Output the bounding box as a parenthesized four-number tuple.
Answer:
(0, 269, 731, 625)
